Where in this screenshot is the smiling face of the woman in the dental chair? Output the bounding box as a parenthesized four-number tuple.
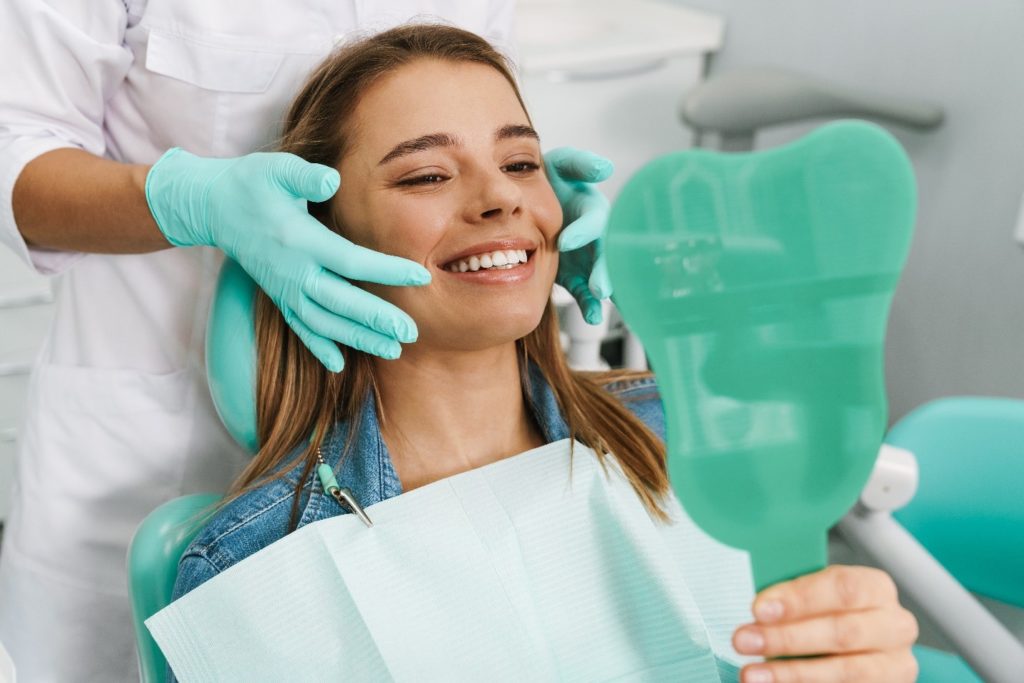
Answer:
(331, 59, 562, 350)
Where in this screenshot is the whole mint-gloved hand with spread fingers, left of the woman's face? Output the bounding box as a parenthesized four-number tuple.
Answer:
(145, 147, 430, 372)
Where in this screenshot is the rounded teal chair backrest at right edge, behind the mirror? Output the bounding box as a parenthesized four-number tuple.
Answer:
(886, 397, 1024, 607)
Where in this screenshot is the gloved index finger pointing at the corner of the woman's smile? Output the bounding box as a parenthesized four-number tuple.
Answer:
(310, 227, 430, 286)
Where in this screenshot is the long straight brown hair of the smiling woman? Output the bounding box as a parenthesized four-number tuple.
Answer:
(228, 24, 669, 529)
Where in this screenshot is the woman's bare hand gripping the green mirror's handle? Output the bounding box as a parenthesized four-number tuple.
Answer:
(732, 565, 918, 683)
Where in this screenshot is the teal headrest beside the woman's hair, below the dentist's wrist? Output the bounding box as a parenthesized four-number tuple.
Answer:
(206, 259, 259, 453)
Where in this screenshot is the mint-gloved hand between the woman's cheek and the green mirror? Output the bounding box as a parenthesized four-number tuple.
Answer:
(544, 147, 614, 325)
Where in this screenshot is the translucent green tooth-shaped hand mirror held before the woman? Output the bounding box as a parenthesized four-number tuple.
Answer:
(606, 121, 915, 590)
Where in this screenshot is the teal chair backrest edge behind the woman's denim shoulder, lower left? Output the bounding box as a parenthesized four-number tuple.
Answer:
(128, 494, 220, 683)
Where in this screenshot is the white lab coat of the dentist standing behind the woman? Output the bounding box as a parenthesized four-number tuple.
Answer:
(0, 0, 513, 683)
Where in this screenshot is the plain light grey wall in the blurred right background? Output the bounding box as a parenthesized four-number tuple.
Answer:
(669, 0, 1024, 420)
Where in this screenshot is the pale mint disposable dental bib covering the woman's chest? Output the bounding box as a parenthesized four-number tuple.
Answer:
(146, 439, 753, 683)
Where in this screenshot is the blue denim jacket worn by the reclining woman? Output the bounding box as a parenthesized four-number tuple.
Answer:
(173, 367, 665, 599)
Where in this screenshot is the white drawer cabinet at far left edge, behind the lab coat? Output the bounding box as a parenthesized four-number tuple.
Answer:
(0, 247, 52, 521)
